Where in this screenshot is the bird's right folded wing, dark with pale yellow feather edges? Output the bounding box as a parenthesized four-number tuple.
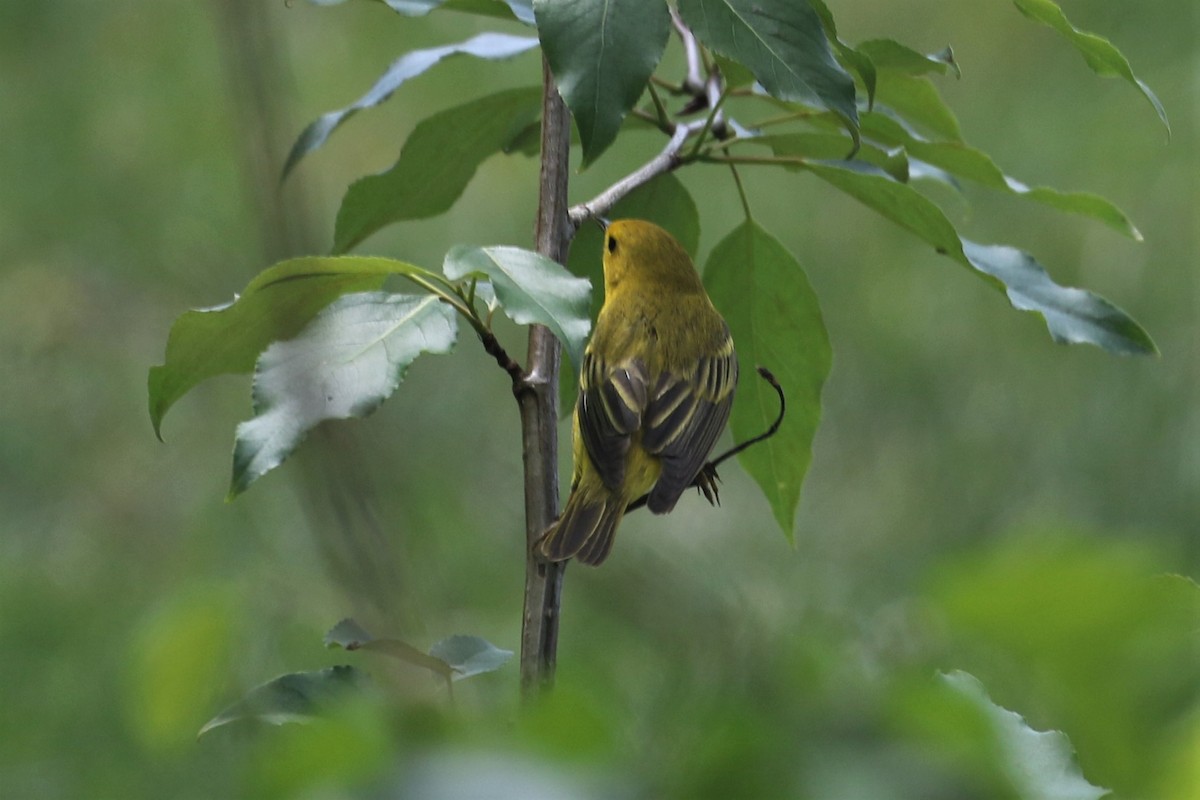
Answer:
(642, 330, 738, 513)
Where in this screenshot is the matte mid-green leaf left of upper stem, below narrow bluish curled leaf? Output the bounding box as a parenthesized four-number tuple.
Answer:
(334, 88, 541, 253)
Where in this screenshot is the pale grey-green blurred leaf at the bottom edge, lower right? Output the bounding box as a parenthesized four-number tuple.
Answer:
(942, 670, 1109, 800)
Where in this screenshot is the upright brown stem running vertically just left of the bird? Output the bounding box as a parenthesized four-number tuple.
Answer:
(517, 59, 571, 698)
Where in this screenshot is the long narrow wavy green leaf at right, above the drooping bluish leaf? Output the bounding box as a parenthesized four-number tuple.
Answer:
(863, 112, 1141, 241)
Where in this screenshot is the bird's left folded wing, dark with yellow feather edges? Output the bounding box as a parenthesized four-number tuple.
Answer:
(575, 351, 647, 489)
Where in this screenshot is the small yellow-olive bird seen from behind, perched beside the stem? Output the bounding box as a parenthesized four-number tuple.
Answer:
(538, 219, 738, 565)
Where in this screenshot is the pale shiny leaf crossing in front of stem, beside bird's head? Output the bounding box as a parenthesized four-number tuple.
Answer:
(443, 245, 592, 368)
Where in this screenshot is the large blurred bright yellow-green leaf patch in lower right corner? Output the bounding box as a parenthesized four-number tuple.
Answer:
(924, 527, 1200, 798)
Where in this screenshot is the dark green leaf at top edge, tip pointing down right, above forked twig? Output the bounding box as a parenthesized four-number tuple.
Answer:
(679, 0, 858, 142)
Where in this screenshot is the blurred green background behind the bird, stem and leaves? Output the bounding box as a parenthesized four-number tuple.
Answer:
(0, 0, 1200, 800)
